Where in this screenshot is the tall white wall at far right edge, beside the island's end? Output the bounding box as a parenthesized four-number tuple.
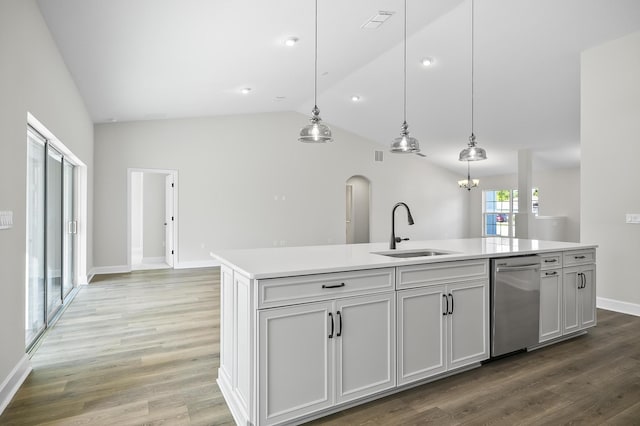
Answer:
(581, 32, 640, 315)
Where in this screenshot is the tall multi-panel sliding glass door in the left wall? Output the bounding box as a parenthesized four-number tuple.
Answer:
(25, 129, 77, 348)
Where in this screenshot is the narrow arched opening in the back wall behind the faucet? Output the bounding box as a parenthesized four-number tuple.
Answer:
(345, 175, 371, 244)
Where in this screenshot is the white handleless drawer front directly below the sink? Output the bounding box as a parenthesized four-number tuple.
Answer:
(396, 259, 489, 290)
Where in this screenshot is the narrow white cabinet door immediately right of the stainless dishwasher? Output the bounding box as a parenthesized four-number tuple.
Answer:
(539, 268, 562, 343)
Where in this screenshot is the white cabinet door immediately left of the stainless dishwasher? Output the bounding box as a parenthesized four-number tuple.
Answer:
(447, 280, 489, 369)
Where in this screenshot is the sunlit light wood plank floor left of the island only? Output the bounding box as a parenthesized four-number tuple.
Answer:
(0, 268, 234, 425)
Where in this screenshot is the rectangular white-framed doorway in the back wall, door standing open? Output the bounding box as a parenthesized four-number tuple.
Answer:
(128, 169, 178, 270)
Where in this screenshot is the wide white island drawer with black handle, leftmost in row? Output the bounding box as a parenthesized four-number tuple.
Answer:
(258, 268, 395, 309)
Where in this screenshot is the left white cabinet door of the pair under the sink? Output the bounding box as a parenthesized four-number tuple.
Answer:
(397, 285, 447, 385)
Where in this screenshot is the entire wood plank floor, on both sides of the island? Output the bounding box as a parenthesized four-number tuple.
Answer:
(0, 268, 640, 425)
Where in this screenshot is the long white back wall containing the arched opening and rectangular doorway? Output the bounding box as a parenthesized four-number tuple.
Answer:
(94, 113, 466, 267)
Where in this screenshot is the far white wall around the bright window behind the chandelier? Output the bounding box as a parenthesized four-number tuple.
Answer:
(469, 167, 580, 242)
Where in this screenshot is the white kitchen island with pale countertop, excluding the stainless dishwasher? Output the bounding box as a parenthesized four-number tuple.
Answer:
(212, 238, 596, 425)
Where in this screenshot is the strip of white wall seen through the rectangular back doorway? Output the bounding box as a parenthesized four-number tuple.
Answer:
(142, 173, 166, 258)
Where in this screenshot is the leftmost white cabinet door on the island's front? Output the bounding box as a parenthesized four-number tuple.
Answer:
(258, 302, 336, 425)
